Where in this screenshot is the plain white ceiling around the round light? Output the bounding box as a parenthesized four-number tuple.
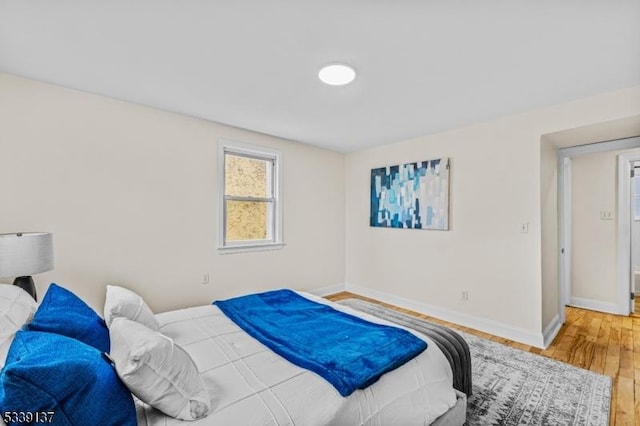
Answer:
(0, 0, 640, 152)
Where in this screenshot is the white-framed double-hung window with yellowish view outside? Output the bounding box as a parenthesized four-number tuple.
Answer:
(218, 141, 283, 252)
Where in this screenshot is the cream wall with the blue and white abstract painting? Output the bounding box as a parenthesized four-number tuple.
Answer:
(346, 87, 640, 345)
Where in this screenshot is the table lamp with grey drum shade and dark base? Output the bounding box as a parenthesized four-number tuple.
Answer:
(0, 232, 53, 300)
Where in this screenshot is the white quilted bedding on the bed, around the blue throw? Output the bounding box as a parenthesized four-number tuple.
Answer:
(136, 293, 456, 426)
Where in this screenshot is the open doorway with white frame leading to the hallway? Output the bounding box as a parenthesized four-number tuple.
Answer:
(558, 138, 640, 321)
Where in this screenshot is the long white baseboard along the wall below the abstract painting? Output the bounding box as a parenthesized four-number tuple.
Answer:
(345, 283, 546, 349)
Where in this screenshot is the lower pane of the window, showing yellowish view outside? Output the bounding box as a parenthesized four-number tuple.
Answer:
(226, 200, 272, 242)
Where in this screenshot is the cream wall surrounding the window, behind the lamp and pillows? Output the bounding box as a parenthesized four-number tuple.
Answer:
(0, 74, 345, 311)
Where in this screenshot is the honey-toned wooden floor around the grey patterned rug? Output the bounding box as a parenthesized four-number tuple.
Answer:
(327, 292, 640, 426)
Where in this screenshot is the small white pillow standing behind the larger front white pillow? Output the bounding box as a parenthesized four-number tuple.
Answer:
(104, 285, 160, 331)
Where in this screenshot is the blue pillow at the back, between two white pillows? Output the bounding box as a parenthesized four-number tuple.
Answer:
(25, 283, 110, 352)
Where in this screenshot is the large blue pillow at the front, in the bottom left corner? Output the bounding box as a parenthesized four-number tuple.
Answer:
(0, 331, 136, 426)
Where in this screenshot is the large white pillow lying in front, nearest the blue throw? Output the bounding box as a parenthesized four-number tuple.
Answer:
(109, 318, 211, 420)
